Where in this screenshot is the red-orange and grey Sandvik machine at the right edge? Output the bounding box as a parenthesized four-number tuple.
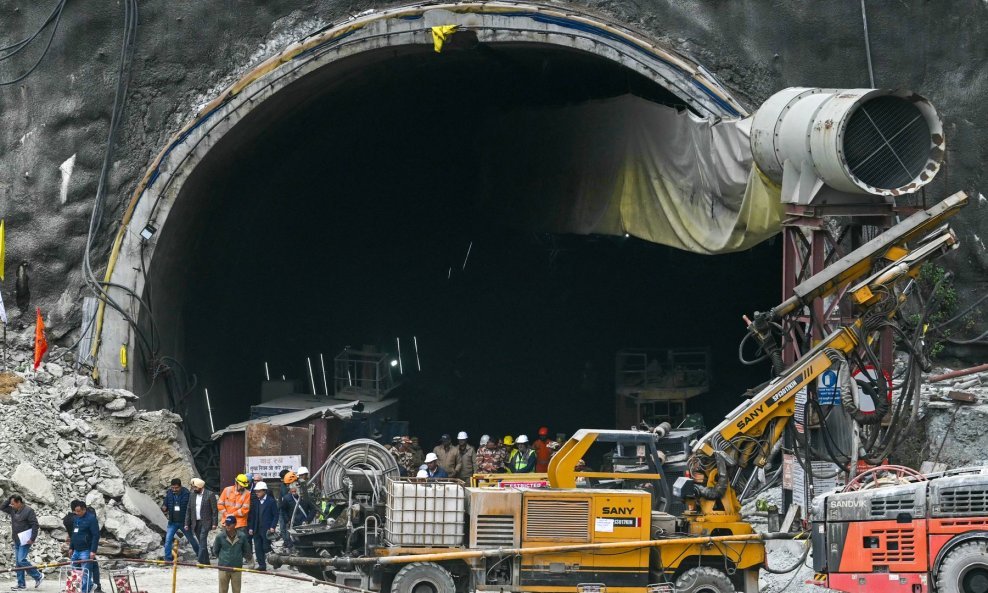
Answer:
(812, 467, 988, 593)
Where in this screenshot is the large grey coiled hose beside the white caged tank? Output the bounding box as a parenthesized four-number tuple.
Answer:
(313, 439, 399, 502)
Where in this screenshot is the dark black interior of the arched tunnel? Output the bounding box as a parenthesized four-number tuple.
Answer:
(135, 46, 781, 443)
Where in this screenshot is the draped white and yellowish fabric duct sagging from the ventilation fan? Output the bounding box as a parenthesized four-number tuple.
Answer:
(481, 95, 783, 254)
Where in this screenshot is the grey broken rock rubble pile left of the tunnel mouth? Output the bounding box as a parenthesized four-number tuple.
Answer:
(0, 338, 195, 567)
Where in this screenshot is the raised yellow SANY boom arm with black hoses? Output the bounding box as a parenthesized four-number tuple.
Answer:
(677, 193, 967, 533)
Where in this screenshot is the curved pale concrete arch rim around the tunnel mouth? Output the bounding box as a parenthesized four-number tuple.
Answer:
(91, 2, 747, 388)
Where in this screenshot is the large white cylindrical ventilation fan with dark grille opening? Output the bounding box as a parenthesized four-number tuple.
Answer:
(751, 88, 944, 204)
